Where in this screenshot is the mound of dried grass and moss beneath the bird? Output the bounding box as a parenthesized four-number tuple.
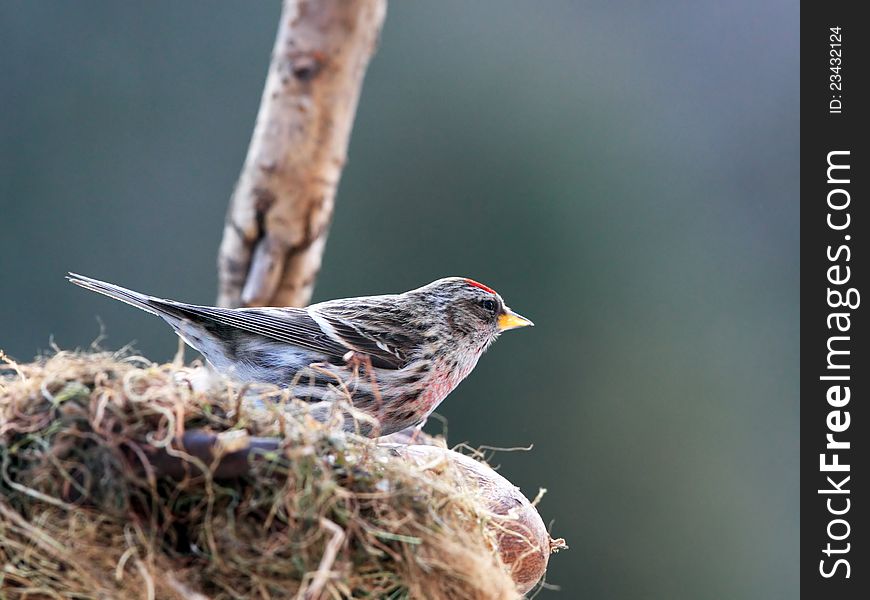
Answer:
(0, 352, 564, 600)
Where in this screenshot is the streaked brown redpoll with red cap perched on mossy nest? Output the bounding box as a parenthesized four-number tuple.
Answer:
(67, 273, 533, 437)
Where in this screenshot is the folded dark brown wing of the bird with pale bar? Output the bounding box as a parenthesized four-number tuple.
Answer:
(152, 300, 406, 369)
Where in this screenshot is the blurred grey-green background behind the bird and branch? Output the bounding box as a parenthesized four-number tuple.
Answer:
(0, 0, 799, 599)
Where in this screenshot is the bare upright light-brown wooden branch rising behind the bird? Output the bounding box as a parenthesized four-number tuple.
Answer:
(218, 0, 386, 307)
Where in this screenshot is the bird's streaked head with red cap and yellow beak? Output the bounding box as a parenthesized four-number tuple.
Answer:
(411, 277, 534, 352)
